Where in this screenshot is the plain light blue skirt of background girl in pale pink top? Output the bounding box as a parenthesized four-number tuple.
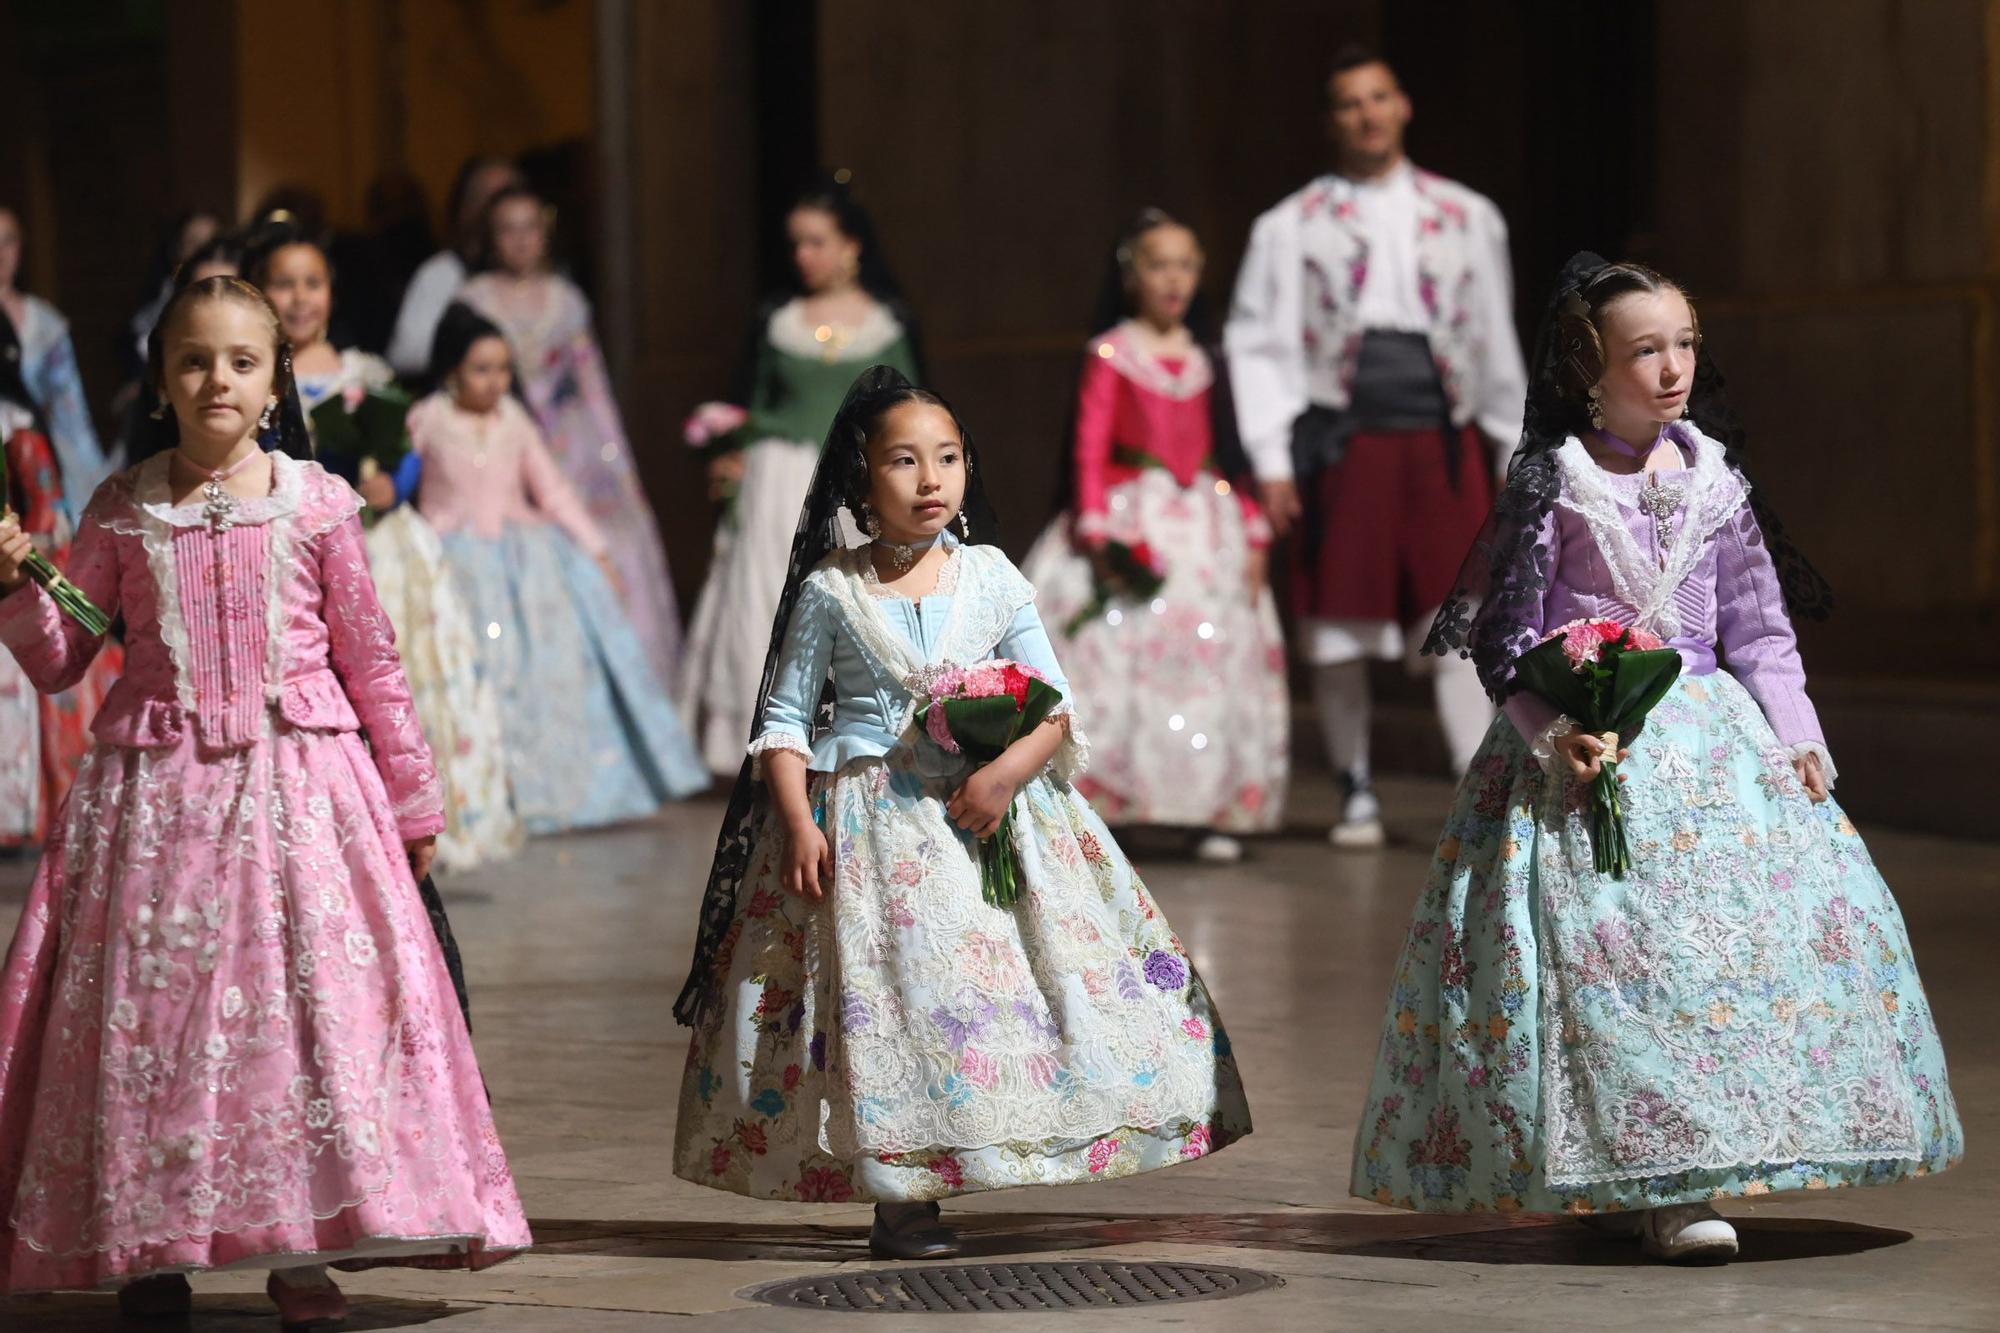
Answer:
(444, 522, 708, 833)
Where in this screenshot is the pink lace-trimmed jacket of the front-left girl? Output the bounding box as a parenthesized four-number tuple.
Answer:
(0, 454, 444, 841)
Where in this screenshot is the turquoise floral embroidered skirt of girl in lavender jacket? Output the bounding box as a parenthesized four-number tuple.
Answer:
(1352, 673, 1964, 1213)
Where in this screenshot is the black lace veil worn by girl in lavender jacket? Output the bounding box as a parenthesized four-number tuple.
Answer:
(1424, 250, 1834, 701)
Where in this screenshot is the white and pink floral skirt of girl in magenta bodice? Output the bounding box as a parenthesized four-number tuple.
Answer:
(1022, 468, 1292, 833)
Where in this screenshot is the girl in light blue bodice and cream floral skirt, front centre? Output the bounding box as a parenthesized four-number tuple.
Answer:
(674, 366, 1250, 1257)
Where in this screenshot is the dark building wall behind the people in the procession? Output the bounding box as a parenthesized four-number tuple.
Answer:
(0, 0, 2000, 820)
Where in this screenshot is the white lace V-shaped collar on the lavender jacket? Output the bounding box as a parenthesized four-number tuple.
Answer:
(1556, 428, 1750, 638)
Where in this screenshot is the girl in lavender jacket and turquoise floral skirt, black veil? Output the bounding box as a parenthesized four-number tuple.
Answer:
(1352, 254, 1964, 1261)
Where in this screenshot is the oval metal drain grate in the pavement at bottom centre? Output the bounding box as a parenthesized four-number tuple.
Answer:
(742, 1263, 1284, 1315)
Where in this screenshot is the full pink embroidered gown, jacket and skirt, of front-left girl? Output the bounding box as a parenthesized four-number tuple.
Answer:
(0, 454, 528, 1291)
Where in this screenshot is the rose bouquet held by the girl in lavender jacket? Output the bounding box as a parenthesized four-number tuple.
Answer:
(1514, 618, 1680, 879)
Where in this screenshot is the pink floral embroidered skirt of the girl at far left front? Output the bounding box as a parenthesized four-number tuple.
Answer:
(0, 727, 528, 1291)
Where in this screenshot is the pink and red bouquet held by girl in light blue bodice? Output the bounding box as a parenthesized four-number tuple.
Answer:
(914, 658, 1062, 907)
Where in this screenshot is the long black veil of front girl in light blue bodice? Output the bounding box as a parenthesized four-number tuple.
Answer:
(674, 366, 1000, 1027)
